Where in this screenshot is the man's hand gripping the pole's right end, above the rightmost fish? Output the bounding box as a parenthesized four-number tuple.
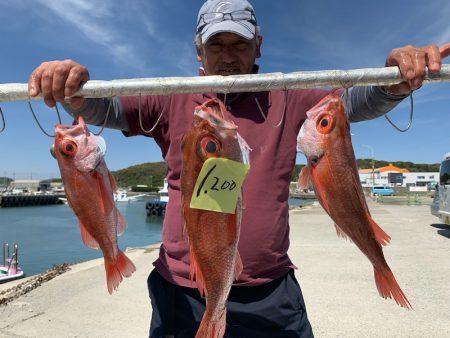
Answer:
(384, 43, 450, 95)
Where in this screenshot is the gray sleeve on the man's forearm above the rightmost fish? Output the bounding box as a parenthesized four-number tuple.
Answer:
(342, 86, 408, 122)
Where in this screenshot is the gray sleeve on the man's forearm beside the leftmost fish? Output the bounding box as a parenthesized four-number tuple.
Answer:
(62, 97, 129, 131)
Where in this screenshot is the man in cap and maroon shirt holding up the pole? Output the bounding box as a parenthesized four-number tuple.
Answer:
(29, 0, 450, 337)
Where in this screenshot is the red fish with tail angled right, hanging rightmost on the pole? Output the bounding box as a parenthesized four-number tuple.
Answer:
(297, 94, 412, 309)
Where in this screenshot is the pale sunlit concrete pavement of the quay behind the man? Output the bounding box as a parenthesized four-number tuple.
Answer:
(0, 200, 450, 338)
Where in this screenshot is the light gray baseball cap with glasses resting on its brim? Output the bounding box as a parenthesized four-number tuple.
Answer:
(197, 0, 257, 43)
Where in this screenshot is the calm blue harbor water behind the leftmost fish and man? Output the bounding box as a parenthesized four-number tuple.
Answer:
(0, 198, 312, 276)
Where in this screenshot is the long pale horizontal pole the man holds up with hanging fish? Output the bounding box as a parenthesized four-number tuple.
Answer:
(0, 64, 450, 102)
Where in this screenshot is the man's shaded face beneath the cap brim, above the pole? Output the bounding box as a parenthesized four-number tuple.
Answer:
(197, 33, 262, 75)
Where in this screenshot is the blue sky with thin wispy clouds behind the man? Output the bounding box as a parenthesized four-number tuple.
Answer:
(0, 0, 450, 179)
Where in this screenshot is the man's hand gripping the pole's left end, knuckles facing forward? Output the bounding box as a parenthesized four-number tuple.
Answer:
(28, 60, 89, 109)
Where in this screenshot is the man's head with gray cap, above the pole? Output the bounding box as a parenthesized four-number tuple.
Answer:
(195, 0, 262, 75)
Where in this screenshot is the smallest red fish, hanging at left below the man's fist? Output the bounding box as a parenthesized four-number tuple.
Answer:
(51, 116, 136, 294)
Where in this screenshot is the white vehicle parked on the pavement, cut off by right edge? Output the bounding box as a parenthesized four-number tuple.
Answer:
(430, 153, 450, 224)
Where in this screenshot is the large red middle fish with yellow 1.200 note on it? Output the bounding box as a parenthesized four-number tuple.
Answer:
(181, 99, 249, 338)
